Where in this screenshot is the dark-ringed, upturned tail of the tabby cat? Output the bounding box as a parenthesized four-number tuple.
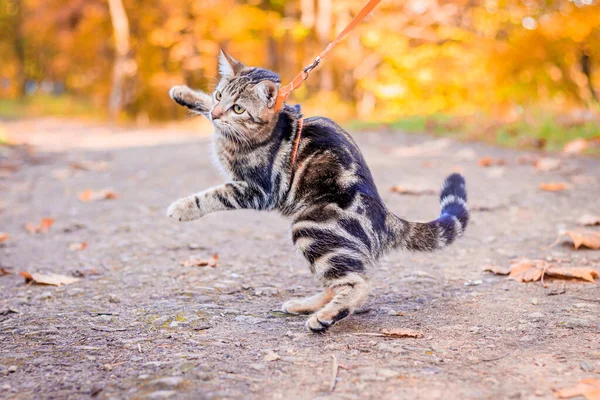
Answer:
(387, 174, 469, 251)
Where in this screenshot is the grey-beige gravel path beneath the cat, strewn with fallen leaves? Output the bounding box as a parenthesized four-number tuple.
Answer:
(0, 120, 600, 399)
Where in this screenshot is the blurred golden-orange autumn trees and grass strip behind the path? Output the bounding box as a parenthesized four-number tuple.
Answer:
(0, 0, 600, 149)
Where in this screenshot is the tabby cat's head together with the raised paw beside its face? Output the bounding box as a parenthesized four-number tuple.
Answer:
(169, 51, 280, 144)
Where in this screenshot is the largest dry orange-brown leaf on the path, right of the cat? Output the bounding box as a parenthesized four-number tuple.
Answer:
(484, 259, 598, 282)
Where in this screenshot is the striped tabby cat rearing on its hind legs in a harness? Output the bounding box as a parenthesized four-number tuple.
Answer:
(167, 51, 469, 333)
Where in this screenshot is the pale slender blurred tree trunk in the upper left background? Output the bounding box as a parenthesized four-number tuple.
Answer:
(108, 0, 130, 120)
